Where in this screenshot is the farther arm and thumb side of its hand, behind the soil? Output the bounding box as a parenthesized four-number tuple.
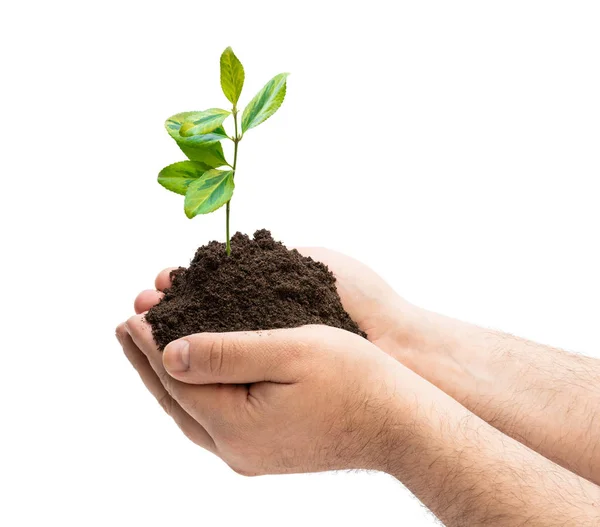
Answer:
(294, 247, 600, 484)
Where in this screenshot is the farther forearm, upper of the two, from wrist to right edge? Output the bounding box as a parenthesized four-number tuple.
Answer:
(388, 311, 600, 483)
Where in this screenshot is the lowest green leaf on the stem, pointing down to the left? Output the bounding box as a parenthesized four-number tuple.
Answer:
(184, 170, 234, 219)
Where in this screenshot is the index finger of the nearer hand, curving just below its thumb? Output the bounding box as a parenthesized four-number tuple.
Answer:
(125, 315, 248, 427)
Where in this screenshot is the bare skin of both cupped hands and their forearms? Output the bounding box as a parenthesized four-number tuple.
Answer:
(122, 252, 600, 526)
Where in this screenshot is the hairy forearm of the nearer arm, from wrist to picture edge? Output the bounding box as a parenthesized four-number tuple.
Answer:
(378, 370, 600, 527)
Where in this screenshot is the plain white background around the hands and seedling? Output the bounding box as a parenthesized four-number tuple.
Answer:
(0, 0, 600, 527)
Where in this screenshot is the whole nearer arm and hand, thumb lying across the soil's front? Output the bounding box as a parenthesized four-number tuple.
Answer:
(117, 317, 600, 527)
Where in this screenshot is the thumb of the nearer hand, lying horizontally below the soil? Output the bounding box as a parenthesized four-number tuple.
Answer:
(163, 326, 323, 384)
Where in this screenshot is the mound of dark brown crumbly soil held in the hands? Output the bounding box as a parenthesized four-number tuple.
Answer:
(146, 230, 365, 350)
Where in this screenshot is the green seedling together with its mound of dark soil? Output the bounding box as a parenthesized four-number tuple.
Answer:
(146, 48, 364, 349)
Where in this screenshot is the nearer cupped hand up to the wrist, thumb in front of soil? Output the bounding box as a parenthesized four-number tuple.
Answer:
(117, 316, 402, 475)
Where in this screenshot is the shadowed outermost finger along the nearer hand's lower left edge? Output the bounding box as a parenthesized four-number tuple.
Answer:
(117, 324, 215, 452)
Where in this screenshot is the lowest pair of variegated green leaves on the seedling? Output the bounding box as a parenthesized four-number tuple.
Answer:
(158, 161, 235, 219)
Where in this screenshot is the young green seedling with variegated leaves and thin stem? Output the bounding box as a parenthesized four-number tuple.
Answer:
(158, 47, 288, 255)
